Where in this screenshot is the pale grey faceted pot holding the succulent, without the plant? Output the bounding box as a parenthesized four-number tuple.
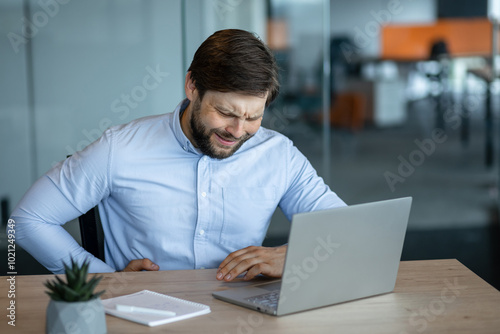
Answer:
(45, 298, 107, 334)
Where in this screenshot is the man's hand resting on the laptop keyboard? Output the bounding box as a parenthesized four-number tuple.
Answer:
(217, 245, 287, 282)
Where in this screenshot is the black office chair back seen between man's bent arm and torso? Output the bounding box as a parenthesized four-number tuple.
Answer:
(78, 206, 104, 261)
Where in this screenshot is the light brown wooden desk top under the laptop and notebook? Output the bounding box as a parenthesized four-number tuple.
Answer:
(0, 260, 500, 334)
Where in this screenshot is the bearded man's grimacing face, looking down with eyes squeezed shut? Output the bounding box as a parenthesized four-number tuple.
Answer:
(190, 91, 266, 159)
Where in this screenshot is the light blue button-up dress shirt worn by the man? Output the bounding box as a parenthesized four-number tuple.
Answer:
(11, 100, 345, 273)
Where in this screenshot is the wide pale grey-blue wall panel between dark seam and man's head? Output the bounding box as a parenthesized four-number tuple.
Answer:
(33, 0, 183, 174)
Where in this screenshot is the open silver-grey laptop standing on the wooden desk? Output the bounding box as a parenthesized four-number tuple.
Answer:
(212, 197, 412, 316)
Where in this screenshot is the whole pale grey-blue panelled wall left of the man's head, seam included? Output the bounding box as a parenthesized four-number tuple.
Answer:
(0, 0, 184, 214)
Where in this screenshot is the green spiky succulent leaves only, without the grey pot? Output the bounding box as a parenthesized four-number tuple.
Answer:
(45, 259, 104, 302)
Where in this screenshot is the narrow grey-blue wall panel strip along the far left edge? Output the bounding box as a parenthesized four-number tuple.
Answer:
(0, 0, 34, 209)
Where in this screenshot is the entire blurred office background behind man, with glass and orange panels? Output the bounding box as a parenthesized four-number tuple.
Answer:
(0, 0, 500, 288)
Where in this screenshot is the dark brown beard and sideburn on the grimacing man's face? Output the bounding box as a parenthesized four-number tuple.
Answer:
(189, 99, 252, 159)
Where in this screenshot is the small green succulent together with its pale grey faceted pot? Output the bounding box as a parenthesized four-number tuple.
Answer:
(45, 259, 107, 334)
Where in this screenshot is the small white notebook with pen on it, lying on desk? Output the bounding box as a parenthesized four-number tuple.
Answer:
(102, 290, 210, 327)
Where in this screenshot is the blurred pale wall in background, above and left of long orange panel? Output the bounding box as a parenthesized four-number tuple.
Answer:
(330, 0, 437, 57)
